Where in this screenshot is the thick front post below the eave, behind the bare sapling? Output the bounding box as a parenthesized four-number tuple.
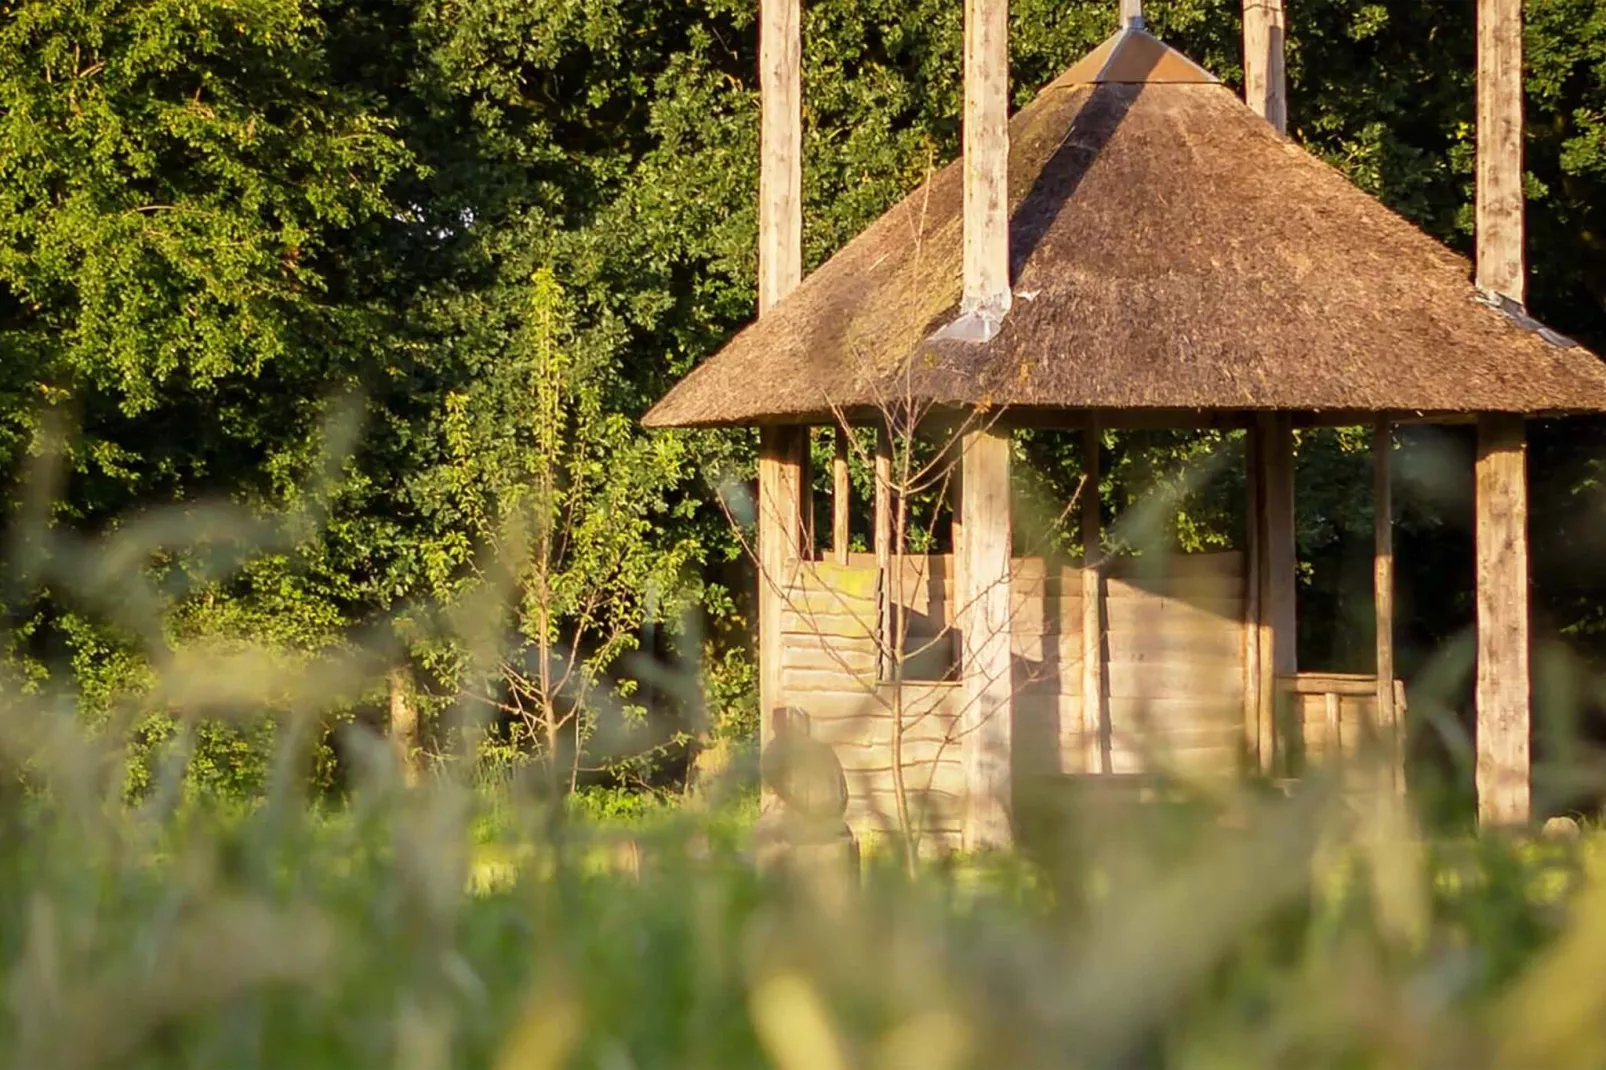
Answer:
(956, 431, 1015, 850)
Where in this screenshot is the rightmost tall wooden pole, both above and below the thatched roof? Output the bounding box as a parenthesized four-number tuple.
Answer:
(1476, 0, 1532, 826)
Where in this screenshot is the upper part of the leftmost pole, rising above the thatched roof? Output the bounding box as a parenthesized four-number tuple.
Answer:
(758, 0, 803, 315)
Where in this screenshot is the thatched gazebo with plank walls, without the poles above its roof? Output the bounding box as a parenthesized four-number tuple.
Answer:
(644, 19, 1606, 843)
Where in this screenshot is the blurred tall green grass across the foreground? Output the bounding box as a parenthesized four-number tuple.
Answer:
(0, 720, 1606, 1070)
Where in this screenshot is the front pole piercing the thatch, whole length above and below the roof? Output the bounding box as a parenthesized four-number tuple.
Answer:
(954, 0, 1015, 848)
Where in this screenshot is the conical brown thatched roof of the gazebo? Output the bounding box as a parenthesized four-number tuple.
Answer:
(646, 29, 1606, 426)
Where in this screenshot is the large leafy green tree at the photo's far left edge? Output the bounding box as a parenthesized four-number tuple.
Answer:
(0, 0, 410, 784)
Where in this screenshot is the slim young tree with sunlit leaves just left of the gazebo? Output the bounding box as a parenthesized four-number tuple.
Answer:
(429, 270, 699, 787)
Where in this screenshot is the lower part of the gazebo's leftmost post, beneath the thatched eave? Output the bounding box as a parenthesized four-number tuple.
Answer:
(758, 427, 808, 802)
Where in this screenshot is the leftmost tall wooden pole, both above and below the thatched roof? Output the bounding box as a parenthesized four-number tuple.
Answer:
(758, 0, 808, 802)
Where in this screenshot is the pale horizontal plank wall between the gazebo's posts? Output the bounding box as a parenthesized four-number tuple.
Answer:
(782, 553, 1245, 848)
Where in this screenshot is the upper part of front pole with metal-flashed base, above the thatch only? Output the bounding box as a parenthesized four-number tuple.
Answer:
(962, 0, 1010, 320)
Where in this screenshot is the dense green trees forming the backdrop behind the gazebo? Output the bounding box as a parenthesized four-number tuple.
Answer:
(0, 0, 1606, 790)
